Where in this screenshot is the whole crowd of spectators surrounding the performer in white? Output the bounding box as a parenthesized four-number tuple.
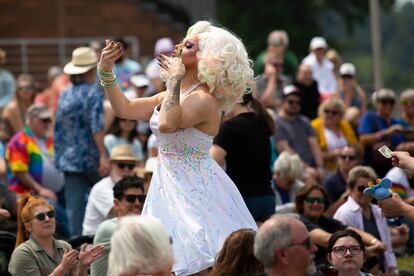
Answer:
(0, 30, 414, 275)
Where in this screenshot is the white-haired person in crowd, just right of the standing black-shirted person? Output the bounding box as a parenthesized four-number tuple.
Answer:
(272, 151, 305, 213)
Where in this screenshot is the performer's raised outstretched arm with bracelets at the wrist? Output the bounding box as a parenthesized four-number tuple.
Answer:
(98, 39, 164, 120)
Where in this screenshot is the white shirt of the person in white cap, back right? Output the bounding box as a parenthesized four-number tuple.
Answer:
(302, 53, 337, 94)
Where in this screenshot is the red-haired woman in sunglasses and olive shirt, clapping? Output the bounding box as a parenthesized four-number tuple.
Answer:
(9, 195, 104, 276)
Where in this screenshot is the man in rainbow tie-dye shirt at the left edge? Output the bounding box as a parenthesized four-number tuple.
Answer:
(6, 104, 56, 199)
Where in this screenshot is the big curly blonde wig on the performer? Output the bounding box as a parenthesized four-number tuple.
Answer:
(161, 21, 253, 112)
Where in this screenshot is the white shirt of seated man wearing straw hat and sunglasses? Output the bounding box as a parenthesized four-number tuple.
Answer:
(82, 176, 115, 235)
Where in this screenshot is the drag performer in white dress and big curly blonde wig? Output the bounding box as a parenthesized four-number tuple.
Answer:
(98, 21, 257, 275)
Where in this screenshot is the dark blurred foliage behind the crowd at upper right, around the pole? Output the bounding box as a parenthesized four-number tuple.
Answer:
(217, 0, 414, 92)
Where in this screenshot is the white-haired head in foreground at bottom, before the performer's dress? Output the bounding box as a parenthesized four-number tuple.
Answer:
(108, 215, 174, 276)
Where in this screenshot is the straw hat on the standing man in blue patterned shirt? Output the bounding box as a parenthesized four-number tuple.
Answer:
(63, 47, 98, 75)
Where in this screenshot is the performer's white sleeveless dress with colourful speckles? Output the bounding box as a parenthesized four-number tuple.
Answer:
(142, 89, 257, 275)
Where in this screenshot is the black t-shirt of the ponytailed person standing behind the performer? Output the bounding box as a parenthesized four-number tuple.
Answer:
(213, 112, 273, 197)
